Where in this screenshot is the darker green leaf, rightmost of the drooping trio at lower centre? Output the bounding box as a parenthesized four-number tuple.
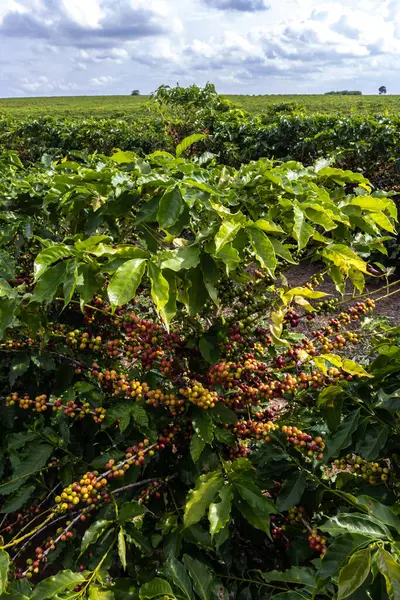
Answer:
(234, 479, 278, 537)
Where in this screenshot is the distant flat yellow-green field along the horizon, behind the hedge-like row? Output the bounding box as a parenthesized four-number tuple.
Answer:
(0, 94, 400, 117)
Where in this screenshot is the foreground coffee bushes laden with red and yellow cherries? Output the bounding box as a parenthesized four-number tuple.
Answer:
(0, 88, 400, 600)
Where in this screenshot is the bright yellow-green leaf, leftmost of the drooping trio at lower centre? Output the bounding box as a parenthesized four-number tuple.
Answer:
(184, 471, 224, 527)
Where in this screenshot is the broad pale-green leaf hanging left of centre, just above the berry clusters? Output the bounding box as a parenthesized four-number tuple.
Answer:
(107, 258, 146, 310)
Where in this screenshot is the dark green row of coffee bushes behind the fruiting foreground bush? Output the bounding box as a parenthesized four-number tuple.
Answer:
(0, 84, 400, 189)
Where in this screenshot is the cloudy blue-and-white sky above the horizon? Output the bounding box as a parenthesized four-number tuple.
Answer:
(0, 0, 400, 97)
